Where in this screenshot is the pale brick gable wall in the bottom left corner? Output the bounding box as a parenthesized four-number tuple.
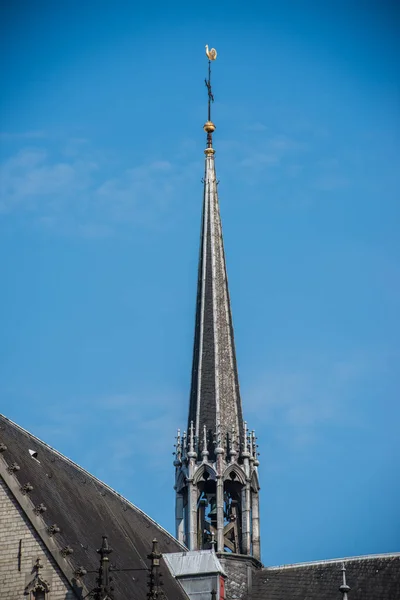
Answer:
(0, 478, 76, 600)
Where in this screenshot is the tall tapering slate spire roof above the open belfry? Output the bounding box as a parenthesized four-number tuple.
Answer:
(188, 148, 243, 459)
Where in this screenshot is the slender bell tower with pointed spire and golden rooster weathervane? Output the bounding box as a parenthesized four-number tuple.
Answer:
(174, 46, 260, 560)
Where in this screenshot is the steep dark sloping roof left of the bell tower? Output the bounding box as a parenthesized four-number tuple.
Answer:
(0, 415, 187, 600)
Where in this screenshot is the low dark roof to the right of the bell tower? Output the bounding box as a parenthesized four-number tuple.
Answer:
(251, 554, 400, 600)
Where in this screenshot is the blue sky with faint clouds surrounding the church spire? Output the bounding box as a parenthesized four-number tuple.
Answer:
(0, 0, 400, 564)
